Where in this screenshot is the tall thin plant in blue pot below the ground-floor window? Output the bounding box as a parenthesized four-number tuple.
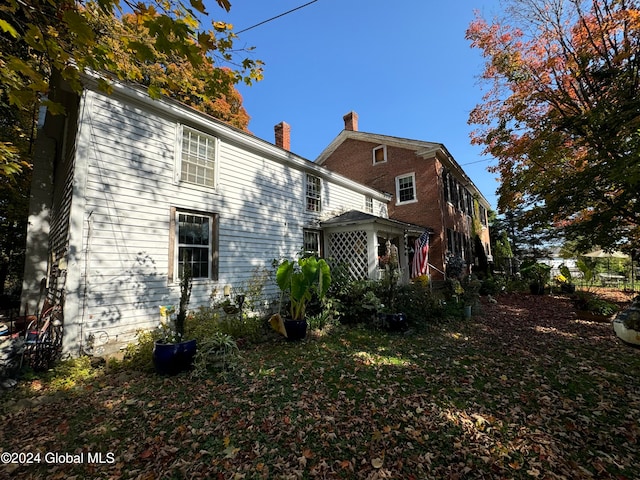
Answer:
(153, 262, 196, 375)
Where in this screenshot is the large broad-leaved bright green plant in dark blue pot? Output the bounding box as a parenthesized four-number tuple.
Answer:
(276, 257, 331, 340)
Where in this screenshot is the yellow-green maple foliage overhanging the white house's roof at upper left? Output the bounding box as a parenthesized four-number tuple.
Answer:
(0, 0, 262, 174)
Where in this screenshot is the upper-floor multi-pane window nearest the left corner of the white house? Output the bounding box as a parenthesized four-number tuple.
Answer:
(180, 127, 216, 188)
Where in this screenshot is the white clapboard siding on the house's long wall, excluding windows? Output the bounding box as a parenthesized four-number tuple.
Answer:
(65, 91, 384, 348)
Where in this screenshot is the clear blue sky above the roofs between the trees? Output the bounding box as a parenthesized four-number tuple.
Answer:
(212, 0, 499, 209)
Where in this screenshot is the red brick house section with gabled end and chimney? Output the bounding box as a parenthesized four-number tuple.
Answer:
(316, 112, 491, 280)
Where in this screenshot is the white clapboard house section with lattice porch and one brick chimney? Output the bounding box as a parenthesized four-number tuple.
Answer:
(22, 75, 428, 355)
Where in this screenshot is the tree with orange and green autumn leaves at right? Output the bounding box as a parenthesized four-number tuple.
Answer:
(467, 0, 640, 253)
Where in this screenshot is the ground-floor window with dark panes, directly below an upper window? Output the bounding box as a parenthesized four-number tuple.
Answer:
(169, 208, 218, 281)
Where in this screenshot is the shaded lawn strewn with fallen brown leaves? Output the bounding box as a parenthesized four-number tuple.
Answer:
(0, 295, 640, 479)
